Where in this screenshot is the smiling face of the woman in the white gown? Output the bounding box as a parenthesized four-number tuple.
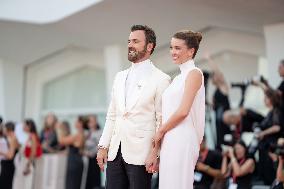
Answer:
(170, 38, 194, 64)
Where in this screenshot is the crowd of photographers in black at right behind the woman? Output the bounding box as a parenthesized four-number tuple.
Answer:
(194, 60, 284, 189)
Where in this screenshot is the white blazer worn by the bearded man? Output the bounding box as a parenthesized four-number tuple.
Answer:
(99, 62, 171, 165)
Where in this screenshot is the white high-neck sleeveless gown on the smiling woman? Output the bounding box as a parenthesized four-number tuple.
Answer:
(159, 60, 205, 189)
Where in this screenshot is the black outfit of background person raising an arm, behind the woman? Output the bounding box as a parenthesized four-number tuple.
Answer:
(213, 88, 231, 150)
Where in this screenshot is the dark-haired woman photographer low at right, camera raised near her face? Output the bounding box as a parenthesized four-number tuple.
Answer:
(221, 141, 255, 189)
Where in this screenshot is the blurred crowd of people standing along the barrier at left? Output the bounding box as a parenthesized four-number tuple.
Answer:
(0, 113, 101, 189)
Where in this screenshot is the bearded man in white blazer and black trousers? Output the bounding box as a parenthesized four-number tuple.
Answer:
(97, 25, 170, 189)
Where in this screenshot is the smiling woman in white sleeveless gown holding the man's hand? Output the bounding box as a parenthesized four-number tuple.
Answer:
(154, 30, 205, 189)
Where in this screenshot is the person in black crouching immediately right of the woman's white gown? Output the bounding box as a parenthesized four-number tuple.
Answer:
(194, 137, 222, 189)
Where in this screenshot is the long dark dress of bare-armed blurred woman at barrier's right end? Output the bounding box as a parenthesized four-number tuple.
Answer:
(65, 146, 83, 189)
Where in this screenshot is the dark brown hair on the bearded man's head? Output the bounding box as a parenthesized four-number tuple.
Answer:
(131, 25, 156, 54)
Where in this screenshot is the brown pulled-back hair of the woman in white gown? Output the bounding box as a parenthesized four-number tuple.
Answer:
(173, 30, 202, 58)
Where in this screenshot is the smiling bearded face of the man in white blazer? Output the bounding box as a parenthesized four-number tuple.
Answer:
(128, 30, 147, 63)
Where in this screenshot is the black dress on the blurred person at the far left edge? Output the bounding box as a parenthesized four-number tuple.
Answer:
(0, 150, 18, 189)
